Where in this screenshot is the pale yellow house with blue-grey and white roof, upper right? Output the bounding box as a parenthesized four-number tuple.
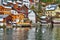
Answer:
(45, 4, 60, 17)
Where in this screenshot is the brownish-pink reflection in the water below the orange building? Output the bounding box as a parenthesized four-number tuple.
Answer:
(13, 28, 28, 40)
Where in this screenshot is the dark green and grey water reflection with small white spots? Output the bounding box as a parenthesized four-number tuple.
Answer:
(36, 24, 52, 40)
